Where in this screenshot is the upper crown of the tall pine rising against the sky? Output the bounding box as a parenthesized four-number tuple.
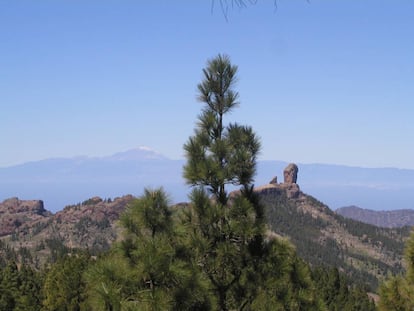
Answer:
(184, 55, 260, 205)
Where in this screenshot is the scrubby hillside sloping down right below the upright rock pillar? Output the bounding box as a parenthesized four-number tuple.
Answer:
(260, 188, 409, 291)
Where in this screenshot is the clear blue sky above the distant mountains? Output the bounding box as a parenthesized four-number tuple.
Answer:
(0, 0, 414, 169)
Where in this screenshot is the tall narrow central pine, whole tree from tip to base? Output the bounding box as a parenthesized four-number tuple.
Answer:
(184, 55, 260, 310)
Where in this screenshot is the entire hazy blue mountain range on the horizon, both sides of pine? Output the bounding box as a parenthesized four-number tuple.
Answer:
(0, 147, 414, 212)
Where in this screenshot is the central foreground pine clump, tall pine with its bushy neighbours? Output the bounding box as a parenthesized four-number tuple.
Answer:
(86, 55, 323, 311)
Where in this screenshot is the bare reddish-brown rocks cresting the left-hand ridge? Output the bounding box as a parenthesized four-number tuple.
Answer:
(0, 195, 134, 243)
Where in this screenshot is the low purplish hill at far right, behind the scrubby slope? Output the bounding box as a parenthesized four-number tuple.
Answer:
(335, 206, 414, 228)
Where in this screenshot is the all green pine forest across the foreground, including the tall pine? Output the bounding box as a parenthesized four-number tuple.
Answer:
(0, 55, 414, 311)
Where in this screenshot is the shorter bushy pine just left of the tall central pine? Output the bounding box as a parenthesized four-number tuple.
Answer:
(87, 189, 209, 310)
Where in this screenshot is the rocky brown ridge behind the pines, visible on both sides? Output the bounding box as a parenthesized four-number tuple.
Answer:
(0, 166, 409, 289)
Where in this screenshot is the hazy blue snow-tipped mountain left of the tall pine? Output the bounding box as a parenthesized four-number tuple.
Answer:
(0, 147, 187, 212)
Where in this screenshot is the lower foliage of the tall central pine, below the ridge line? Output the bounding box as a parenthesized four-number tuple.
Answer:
(184, 188, 257, 309)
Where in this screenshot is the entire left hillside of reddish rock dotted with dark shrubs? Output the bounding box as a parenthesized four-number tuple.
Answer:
(0, 195, 134, 266)
